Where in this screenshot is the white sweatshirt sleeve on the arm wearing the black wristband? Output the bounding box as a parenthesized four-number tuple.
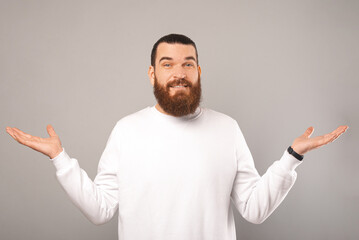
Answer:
(231, 124, 301, 224)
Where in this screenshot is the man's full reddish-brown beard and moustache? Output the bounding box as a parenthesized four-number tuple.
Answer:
(153, 74, 202, 117)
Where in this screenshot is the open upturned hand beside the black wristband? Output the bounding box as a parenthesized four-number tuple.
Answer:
(292, 126, 349, 155)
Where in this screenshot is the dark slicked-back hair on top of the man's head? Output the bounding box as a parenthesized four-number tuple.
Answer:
(151, 33, 198, 67)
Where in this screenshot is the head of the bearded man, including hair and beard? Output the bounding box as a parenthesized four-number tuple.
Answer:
(148, 34, 201, 116)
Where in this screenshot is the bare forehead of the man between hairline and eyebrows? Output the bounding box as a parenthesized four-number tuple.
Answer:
(156, 42, 197, 61)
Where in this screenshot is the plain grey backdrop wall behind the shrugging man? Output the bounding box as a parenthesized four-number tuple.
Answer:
(0, 0, 359, 240)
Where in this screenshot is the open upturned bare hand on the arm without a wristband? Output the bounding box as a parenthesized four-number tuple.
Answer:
(6, 125, 62, 158)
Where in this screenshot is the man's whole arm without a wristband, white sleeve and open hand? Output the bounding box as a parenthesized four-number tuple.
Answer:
(7, 125, 118, 225)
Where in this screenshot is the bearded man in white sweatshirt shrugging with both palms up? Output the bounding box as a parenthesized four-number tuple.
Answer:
(7, 34, 348, 240)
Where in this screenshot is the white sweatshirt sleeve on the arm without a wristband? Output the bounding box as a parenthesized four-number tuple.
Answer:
(50, 125, 119, 225)
